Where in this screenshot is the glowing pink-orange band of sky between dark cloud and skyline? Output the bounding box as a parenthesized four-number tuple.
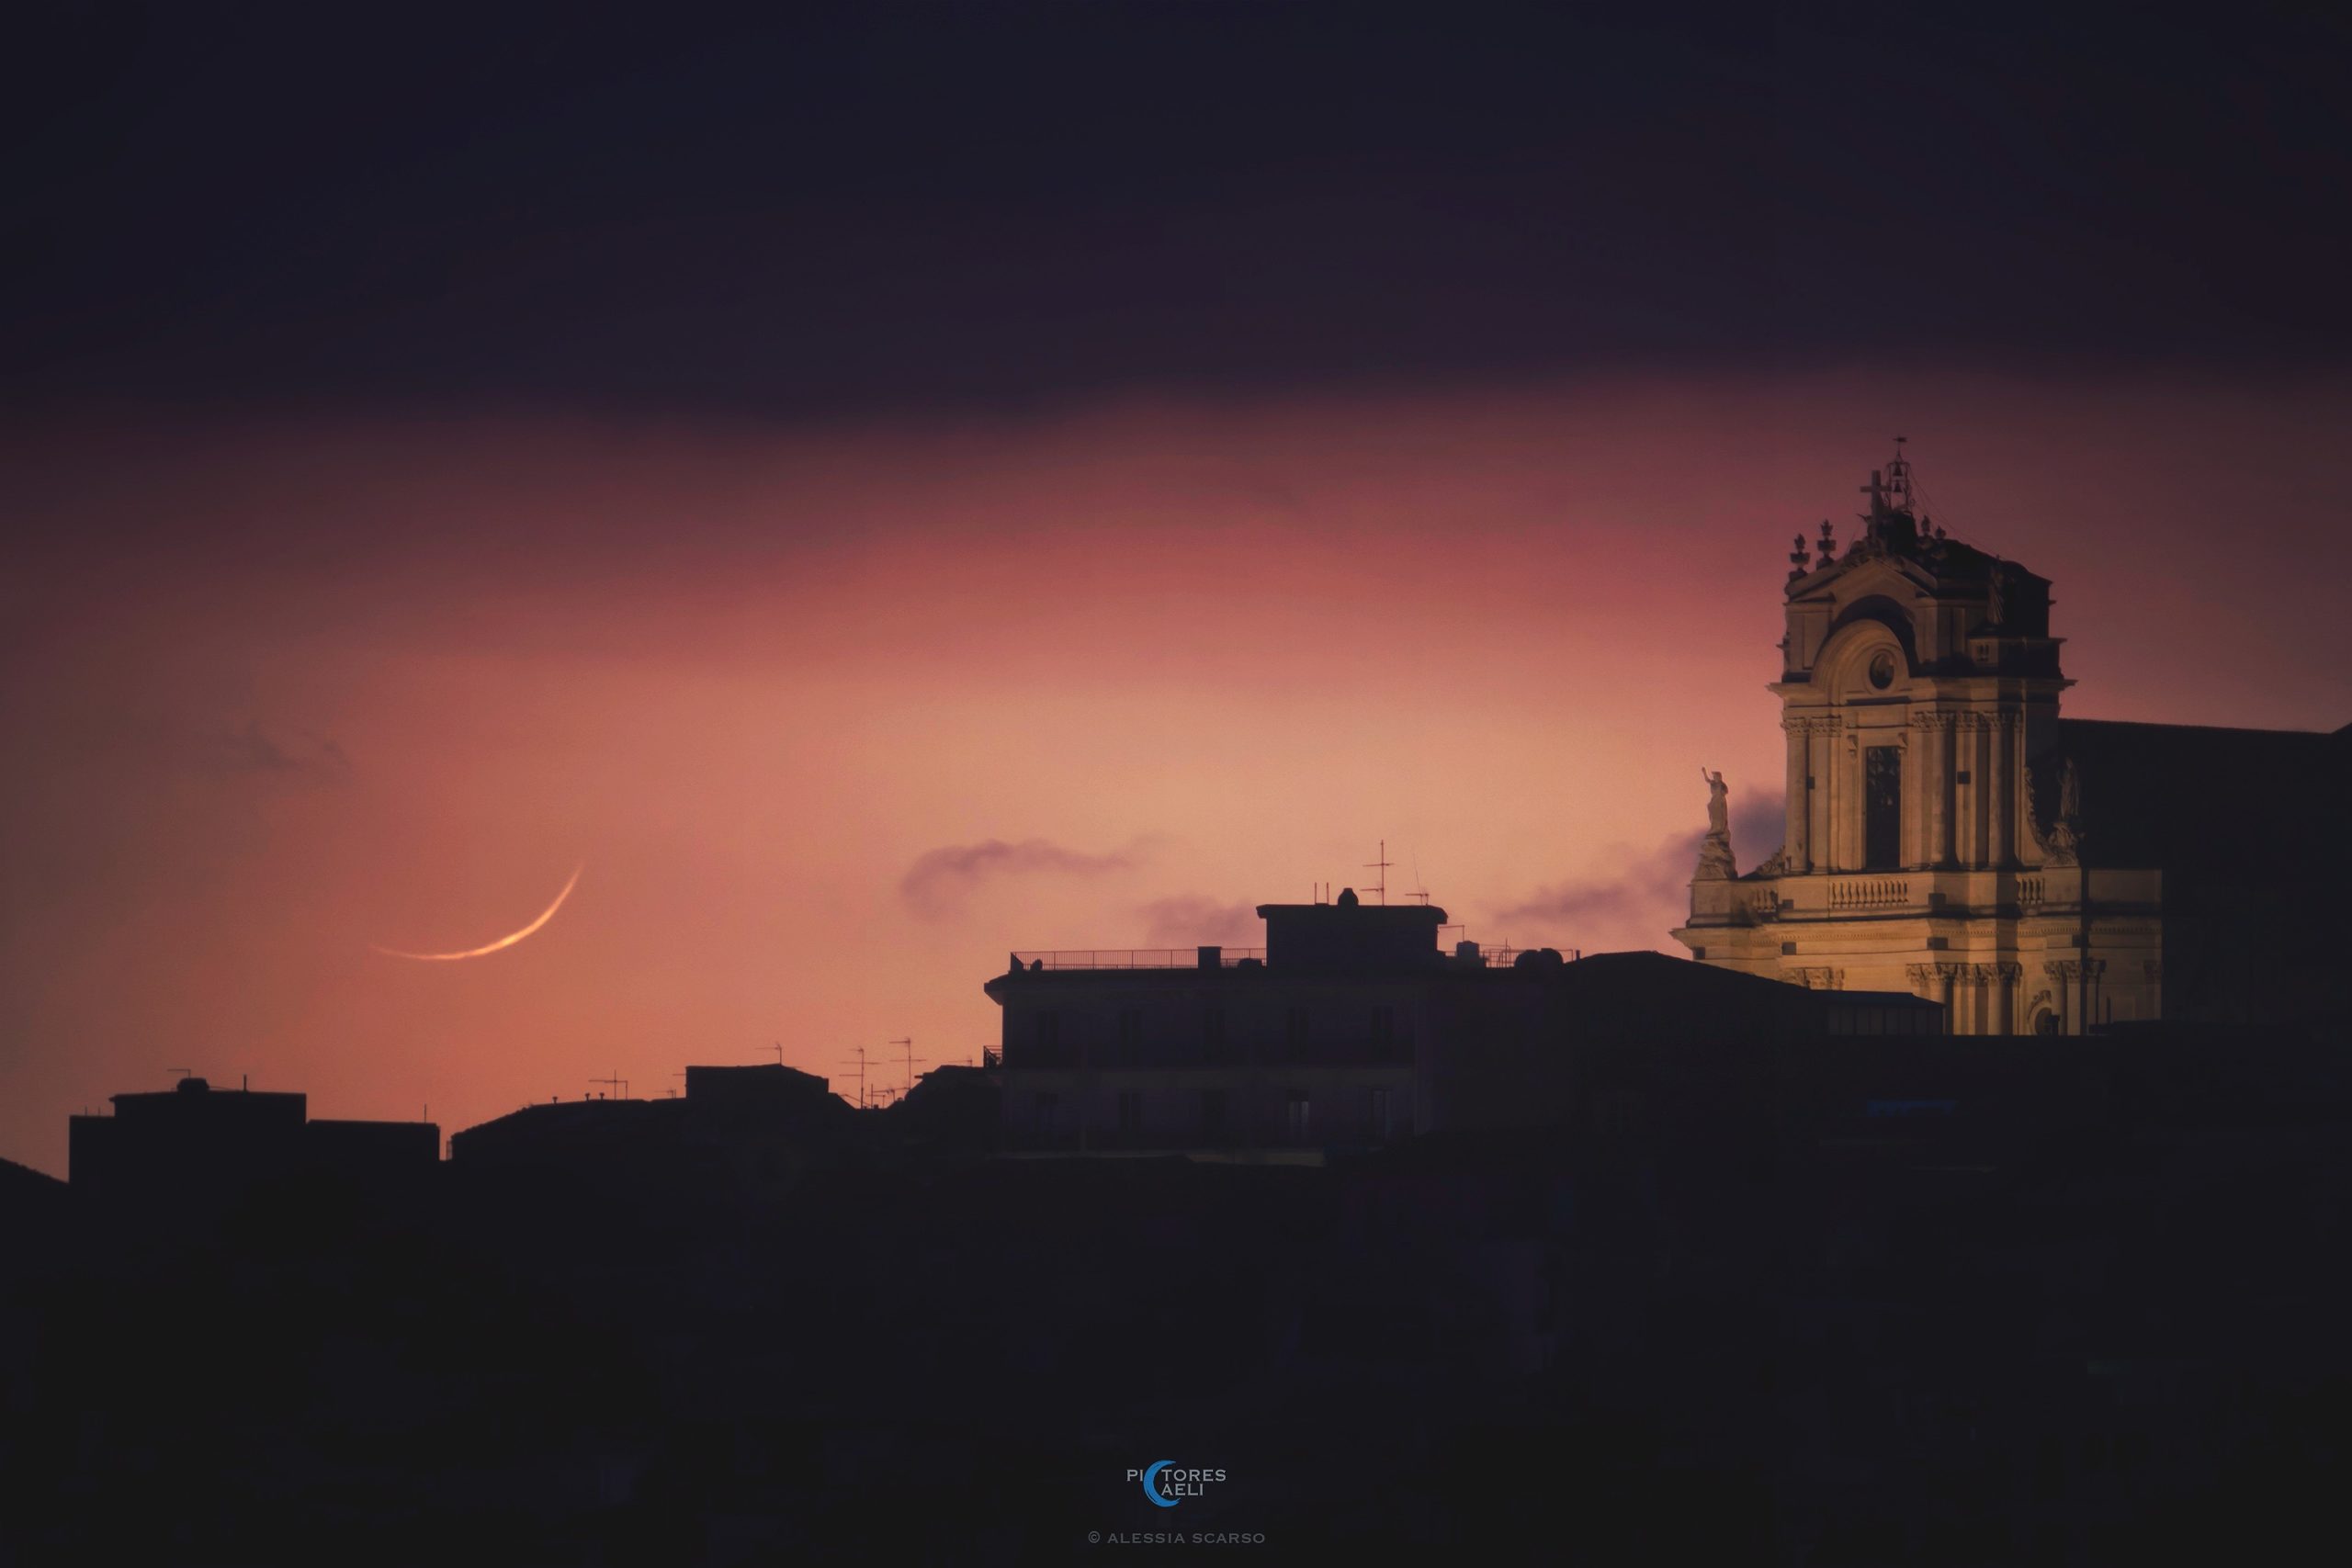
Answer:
(0, 374, 2352, 1173)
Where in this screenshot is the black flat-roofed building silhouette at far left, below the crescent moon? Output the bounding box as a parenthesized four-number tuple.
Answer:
(66, 1077, 440, 1201)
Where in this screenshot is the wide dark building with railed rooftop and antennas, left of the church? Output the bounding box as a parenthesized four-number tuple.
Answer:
(986, 891, 1943, 1164)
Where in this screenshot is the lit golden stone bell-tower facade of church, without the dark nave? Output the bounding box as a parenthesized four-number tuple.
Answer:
(1675, 437, 2157, 1034)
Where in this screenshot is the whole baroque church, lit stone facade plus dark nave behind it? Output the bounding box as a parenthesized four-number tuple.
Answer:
(1675, 446, 2352, 1034)
